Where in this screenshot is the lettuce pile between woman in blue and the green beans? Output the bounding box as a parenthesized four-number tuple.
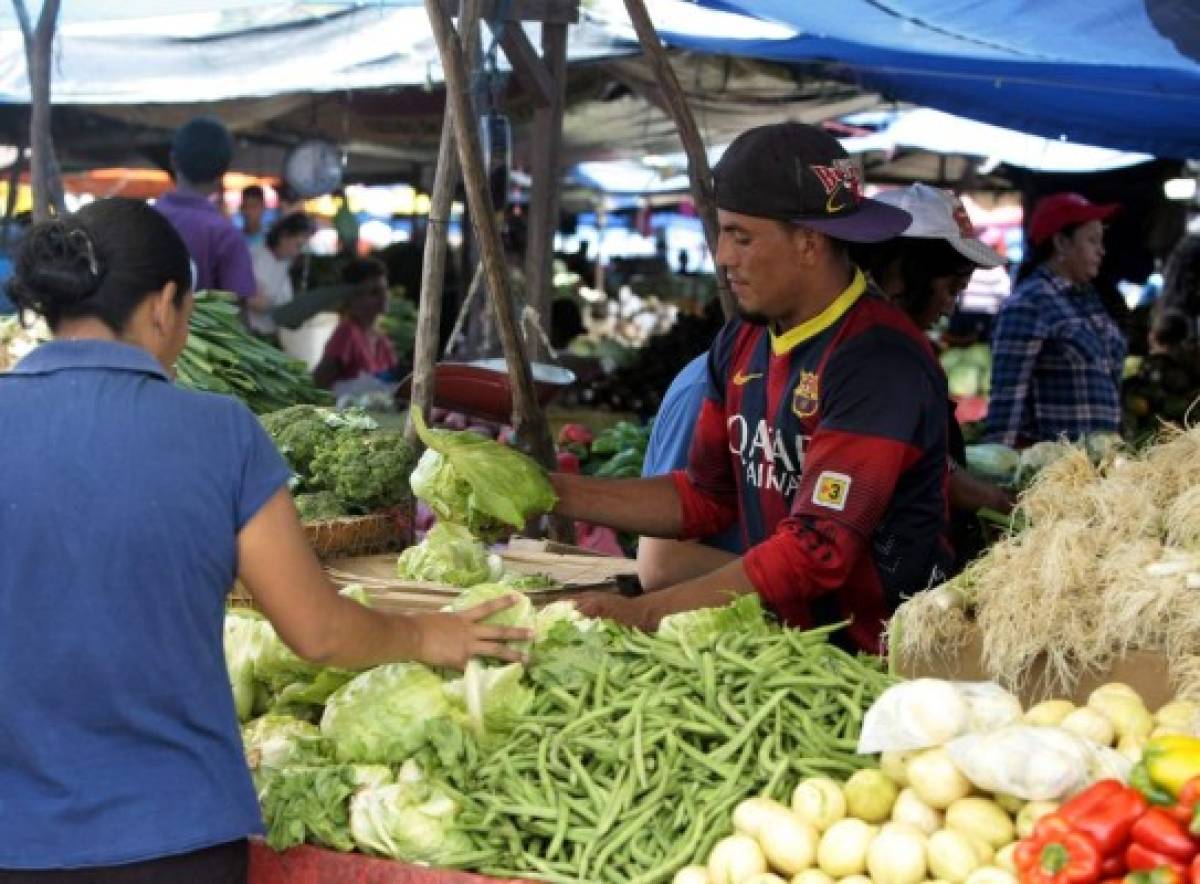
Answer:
(224, 583, 547, 865)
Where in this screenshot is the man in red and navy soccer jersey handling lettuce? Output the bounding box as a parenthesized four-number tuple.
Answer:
(553, 124, 950, 651)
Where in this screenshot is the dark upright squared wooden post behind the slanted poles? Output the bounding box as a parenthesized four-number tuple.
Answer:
(526, 24, 566, 355)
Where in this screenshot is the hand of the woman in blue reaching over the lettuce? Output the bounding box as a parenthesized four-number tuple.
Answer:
(413, 594, 533, 669)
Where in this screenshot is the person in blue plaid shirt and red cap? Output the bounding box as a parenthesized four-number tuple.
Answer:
(986, 193, 1127, 447)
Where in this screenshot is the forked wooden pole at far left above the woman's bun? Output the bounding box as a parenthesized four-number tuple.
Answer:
(12, 0, 66, 222)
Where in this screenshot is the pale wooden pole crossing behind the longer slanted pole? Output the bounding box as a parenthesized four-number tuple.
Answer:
(406, 0, 480, 444)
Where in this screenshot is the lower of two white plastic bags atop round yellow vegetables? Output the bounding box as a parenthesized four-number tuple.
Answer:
(946, 724, 1099, 801)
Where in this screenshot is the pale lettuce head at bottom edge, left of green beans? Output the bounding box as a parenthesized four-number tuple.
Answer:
(350, 780, 472, 865)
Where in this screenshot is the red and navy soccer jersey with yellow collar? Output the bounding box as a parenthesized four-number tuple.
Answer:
(674, 271, 950, 653)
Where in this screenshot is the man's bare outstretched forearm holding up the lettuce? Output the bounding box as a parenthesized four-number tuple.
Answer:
(550, 473, 683, 537)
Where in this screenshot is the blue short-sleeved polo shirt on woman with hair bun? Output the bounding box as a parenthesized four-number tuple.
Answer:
(0, 341, 289, 870)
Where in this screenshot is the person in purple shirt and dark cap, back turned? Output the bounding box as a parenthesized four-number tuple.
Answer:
(155, 116, 257, 300)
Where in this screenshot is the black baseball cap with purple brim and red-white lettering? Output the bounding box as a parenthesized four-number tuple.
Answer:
(713, 122, 912, 242)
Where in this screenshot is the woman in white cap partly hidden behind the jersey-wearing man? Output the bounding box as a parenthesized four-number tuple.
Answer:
(854, 184, 1013, 567)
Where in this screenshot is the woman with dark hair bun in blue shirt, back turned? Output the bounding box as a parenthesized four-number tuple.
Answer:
(0, 199, 528, 884)
